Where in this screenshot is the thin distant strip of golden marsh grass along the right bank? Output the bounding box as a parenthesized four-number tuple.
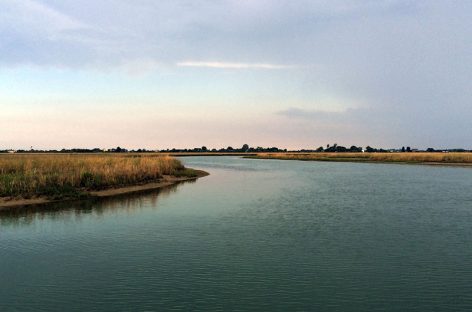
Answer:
(249, 153, 472, 165)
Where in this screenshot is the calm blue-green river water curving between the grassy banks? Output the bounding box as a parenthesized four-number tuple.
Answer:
(0, 157, 472, 311)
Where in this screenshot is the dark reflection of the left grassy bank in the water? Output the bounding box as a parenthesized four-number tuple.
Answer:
(0, 180, 195, 226)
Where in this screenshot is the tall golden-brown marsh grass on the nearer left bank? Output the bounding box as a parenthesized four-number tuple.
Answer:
(0, 154, 201, 199)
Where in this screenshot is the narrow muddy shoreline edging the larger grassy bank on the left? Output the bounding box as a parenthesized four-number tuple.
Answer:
(0, 170, 210, 210)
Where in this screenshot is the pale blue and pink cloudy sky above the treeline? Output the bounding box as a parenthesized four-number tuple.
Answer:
(0, 0, 472, 149)
